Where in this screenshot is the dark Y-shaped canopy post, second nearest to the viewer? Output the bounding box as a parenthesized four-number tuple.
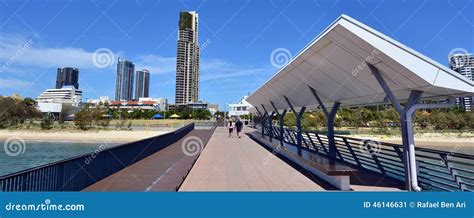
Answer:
(308, 85, 341, 163)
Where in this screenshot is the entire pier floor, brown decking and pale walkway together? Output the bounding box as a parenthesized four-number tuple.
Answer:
(83, 127, 402, 191)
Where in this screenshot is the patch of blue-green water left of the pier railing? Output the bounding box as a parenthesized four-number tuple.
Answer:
(0, 141, 120, 175)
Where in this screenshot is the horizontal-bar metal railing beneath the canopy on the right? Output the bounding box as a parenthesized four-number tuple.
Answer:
(257, 123, 474, 191)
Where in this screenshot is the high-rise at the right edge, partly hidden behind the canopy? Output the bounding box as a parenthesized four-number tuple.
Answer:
(449, 54, 474, 111)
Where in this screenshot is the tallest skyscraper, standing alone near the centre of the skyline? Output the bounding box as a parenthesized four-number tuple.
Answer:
(175, 11, 199, 104)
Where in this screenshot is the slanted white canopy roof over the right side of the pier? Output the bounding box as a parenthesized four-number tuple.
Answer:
(247, 15, 474, 111)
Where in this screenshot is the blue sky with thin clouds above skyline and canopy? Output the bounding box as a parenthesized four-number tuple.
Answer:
(0, 0, 474, 109)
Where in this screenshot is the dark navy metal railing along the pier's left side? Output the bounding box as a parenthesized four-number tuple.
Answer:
(0, 123, 194, 191)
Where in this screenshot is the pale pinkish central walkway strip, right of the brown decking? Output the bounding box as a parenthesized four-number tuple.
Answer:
(180, 127, 324, 191)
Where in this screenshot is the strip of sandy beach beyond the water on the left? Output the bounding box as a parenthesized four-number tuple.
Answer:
(0, 130, 169, 142)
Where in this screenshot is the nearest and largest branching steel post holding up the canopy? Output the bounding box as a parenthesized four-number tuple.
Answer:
(367, 63, 455, 191)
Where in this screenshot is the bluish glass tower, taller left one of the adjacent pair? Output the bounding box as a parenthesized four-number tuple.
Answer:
(115, 58, 135, 101)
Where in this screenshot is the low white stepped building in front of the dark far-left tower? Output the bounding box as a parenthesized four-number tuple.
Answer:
(36, 86, 82, 116)
